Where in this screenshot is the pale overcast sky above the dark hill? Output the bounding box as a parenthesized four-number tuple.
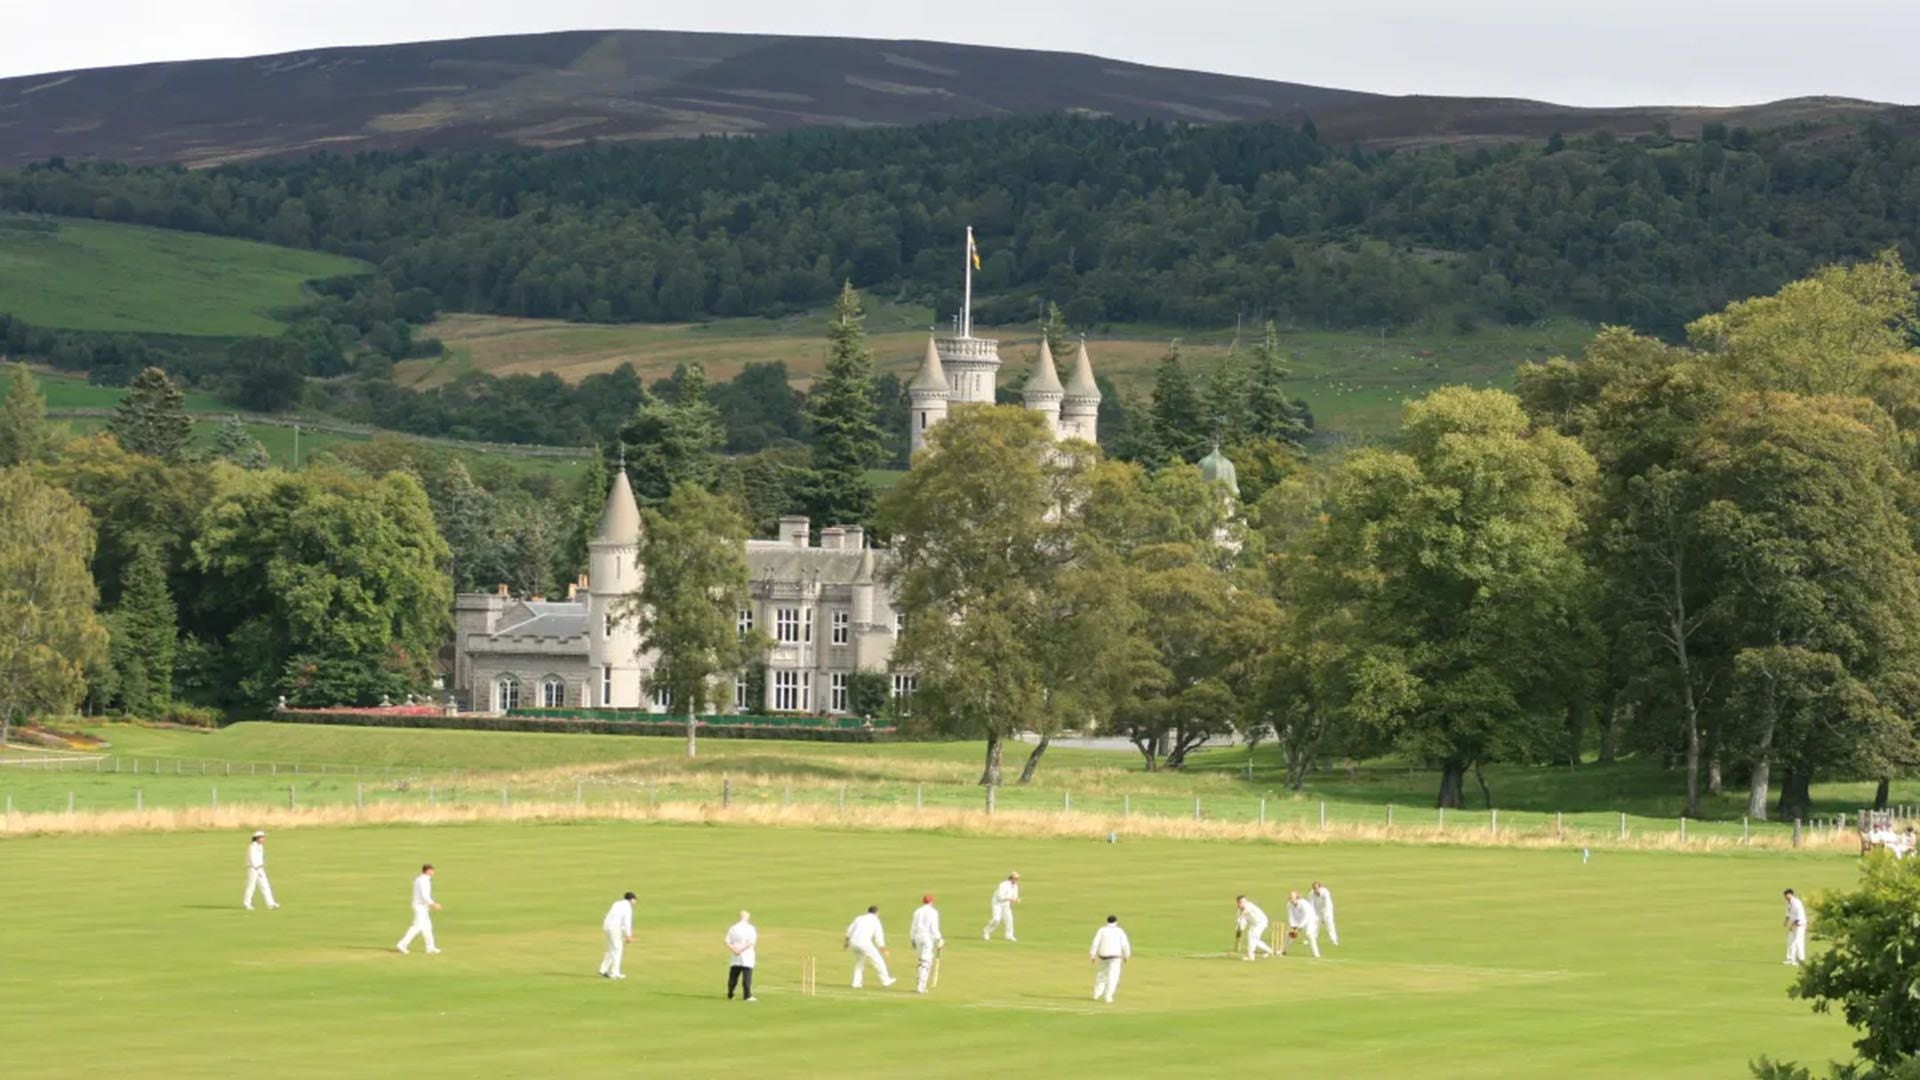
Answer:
(0, 0, 1920, 106)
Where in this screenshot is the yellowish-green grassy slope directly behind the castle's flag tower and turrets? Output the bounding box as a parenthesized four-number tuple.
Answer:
(396, 304, 1594, 436)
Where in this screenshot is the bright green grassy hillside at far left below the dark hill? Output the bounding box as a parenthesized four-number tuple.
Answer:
(0, 213, 367, 336)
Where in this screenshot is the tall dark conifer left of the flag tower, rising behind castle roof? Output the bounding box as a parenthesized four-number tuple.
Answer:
(803, 282, 887, 525)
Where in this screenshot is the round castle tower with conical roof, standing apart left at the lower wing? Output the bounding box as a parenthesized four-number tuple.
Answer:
(588, 461, 645, 709)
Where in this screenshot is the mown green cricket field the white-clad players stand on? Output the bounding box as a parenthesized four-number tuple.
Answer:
(0, 824, 1857, 1078)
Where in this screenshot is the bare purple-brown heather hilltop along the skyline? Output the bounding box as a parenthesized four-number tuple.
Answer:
(0, 31, 1887, 165)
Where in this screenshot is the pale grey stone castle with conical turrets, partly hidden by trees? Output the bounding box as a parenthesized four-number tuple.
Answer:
(451, 329, 1100, 715)
